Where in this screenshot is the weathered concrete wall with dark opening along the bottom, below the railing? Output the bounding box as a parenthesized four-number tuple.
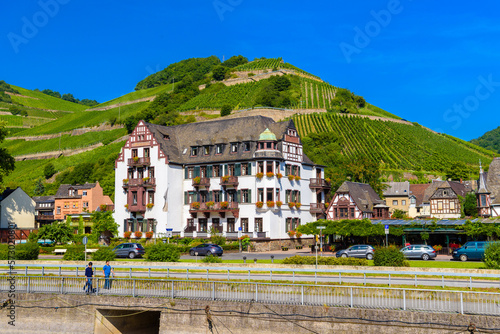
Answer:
(0, 293, 500, 334)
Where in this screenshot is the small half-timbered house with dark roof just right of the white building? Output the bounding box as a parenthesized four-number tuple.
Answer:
(326, 181, 389, 220)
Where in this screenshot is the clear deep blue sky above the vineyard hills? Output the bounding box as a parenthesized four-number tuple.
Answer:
(0, 0, 500, 140)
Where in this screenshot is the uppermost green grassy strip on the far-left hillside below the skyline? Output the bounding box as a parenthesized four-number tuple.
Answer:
(11, 85, 88, 111)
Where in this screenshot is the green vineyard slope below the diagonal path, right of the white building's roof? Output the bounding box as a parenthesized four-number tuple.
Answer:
(294, 113, 494, 171)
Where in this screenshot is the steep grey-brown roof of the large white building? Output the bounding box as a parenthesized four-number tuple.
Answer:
(145, 116, 314, 165)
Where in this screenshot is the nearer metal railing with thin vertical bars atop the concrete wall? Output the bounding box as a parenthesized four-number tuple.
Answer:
(0, 276, 500, 316)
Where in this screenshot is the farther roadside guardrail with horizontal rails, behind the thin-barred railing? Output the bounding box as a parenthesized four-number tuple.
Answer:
(0, 259, 500, 289)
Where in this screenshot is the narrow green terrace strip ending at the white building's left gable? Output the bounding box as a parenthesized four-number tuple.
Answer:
(0, 129, 127, 156)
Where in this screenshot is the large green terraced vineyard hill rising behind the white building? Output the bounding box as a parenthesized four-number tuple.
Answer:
(0, 56, 494, 201)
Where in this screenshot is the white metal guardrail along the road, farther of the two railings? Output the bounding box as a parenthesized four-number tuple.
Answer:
(0, 260, 500, 289)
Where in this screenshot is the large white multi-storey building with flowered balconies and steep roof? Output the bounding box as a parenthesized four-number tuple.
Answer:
(115, 116, 328, 239)
